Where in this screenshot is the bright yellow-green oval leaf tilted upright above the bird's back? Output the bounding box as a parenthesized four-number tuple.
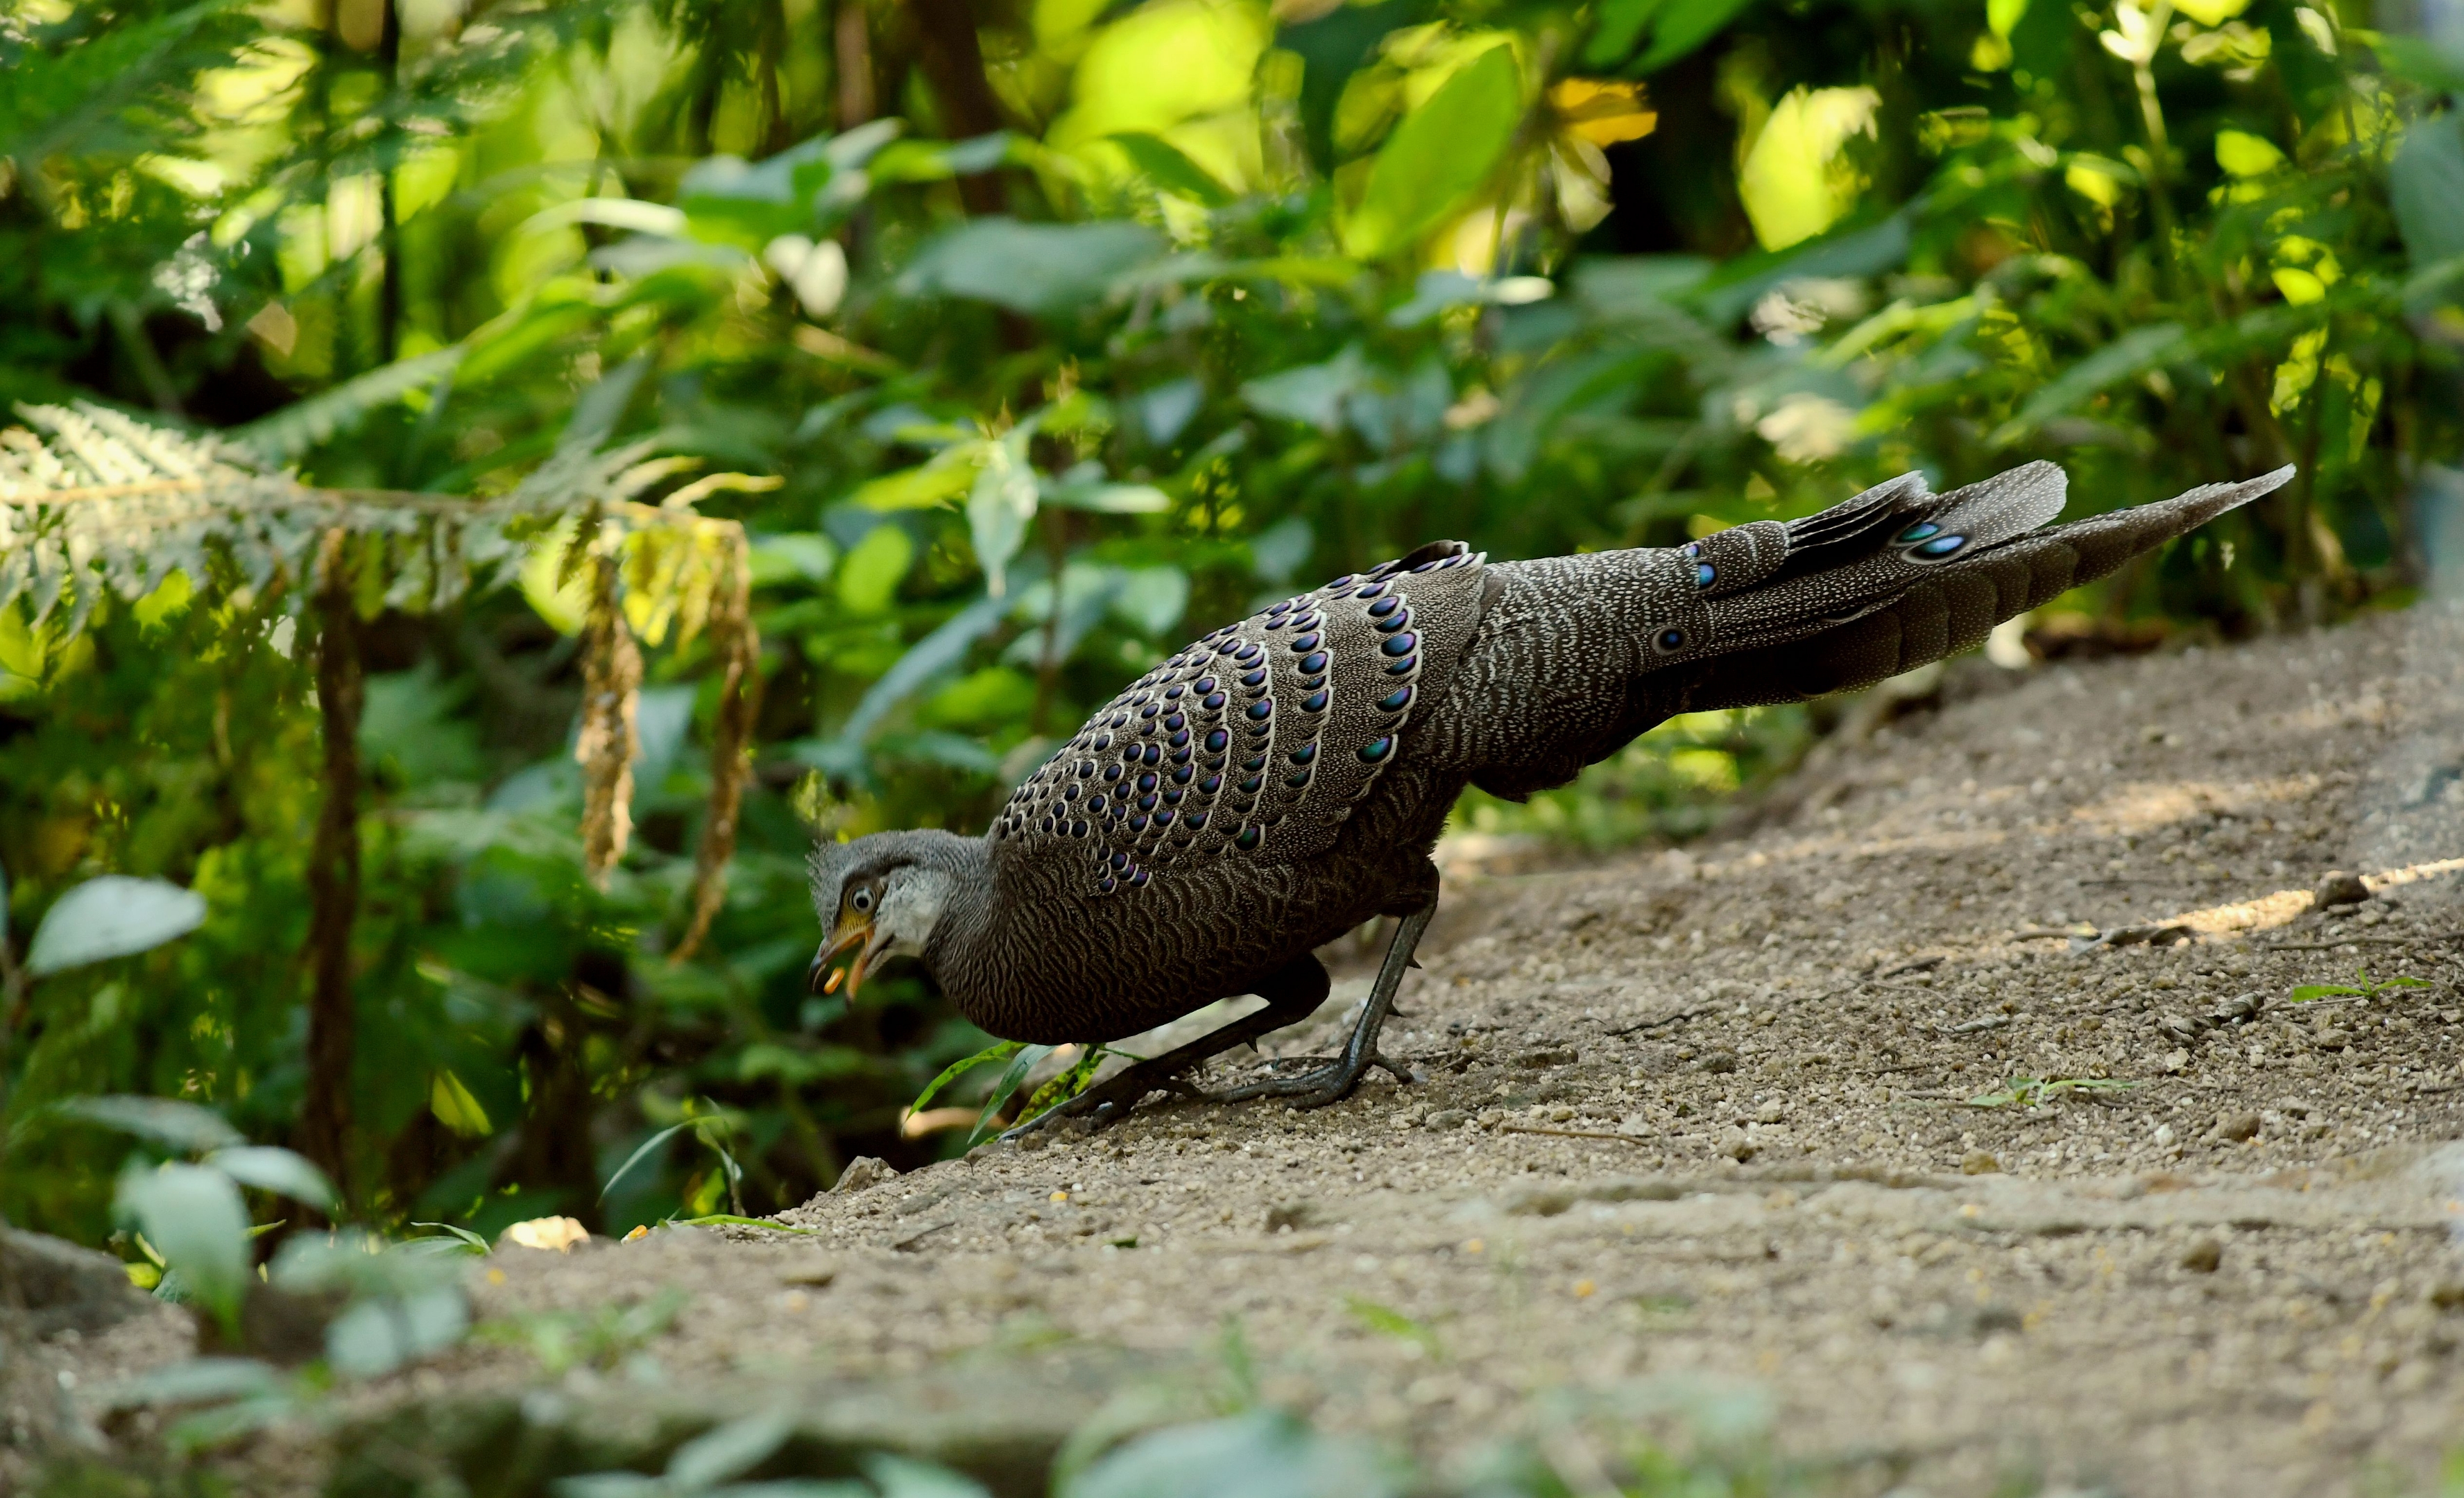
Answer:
(1343, 42, 1523, 259)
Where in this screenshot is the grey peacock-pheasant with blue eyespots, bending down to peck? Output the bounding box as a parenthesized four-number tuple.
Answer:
(813, 463, 2291, 1116)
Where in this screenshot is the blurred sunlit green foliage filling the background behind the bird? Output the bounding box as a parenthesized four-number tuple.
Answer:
(0, 0, 2464, 1257)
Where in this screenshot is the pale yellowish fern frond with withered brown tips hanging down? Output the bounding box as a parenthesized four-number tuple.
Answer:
(0, 404, 762, 951)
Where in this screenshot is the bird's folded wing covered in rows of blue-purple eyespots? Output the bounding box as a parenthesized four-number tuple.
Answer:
(991, 542, 1486, 895)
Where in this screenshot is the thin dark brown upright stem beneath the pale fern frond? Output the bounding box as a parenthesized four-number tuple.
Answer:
(298, 530, 362, 1200)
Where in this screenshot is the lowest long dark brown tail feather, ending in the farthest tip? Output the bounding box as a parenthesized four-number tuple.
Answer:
(1683, 465, 2294, 709)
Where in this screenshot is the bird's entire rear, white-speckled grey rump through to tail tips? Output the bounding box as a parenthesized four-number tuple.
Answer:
(1437, 463, 2291, 798)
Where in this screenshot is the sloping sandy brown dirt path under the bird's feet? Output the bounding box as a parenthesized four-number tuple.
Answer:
(43, 611, 2464, 1495)
